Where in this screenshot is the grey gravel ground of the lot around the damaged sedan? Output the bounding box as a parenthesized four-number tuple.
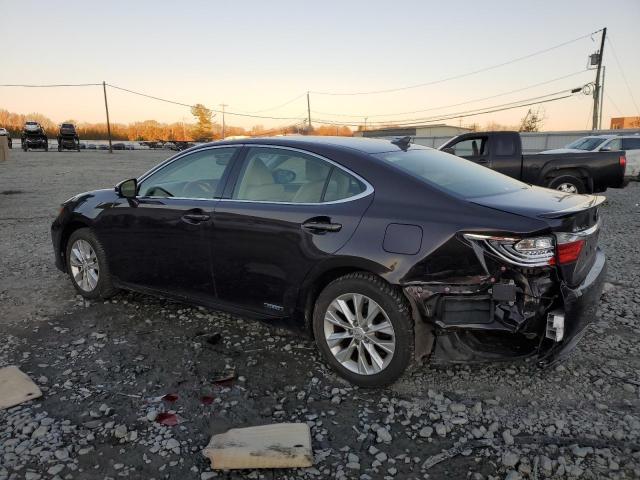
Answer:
(0, 150, 640, 480)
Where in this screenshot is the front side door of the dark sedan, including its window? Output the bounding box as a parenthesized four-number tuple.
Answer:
(96, 147, 240, 301)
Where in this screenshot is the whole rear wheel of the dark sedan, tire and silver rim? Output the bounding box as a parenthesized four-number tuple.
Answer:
(313, 272, 414, 387)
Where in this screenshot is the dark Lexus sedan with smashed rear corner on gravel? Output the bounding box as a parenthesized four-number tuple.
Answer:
(51, 137, 605, 386)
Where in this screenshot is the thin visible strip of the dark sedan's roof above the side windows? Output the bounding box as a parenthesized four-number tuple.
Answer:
(192, 135, 428, 153)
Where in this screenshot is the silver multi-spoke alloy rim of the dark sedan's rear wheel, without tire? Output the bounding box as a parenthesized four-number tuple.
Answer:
(324, 293, 396, 375)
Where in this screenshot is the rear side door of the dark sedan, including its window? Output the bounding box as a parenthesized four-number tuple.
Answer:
(211, 146, 373, 315)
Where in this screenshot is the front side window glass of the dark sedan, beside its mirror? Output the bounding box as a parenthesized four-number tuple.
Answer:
(139, 147, 237, 199)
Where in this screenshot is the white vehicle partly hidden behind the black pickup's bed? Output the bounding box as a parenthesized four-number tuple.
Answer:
(541, 134, 640, 181)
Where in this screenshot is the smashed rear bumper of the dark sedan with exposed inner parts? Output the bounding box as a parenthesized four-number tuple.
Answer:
(403, 249, 606, 367)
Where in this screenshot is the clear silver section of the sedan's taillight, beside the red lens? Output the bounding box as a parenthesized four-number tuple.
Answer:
(464, 233, 555, 267)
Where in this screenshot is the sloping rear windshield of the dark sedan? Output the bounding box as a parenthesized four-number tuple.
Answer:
(375, 149, 528, 198)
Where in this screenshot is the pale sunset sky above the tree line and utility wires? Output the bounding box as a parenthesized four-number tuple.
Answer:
(0, 0, 640, 130)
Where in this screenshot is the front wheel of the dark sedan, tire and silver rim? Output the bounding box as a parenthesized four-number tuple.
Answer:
(65, 228, 118, 300)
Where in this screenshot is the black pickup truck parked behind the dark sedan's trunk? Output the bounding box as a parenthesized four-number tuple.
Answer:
(439, 132, 627, 193)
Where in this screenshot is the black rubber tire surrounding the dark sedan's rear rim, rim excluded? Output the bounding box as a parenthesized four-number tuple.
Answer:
(313, 272, 414, 387)
